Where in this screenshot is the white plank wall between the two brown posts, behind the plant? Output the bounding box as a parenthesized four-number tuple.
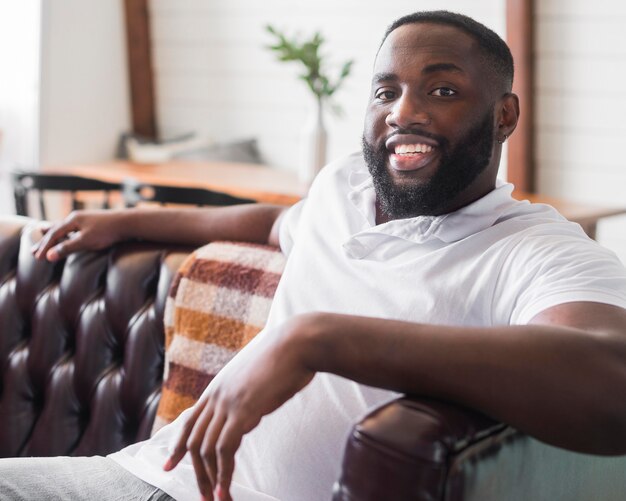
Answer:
(150, 0, 506, 170)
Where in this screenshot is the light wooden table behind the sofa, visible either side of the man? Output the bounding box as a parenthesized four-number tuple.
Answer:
(44, 161, 626, 238)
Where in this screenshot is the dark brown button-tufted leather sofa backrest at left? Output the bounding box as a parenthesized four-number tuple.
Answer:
(0, 218, 189, 456)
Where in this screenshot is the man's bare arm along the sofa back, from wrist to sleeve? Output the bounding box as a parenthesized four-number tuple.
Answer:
(115, 204, 285, 245)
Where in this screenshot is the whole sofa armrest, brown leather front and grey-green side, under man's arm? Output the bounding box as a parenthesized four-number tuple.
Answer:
(333, 397, 626, 501)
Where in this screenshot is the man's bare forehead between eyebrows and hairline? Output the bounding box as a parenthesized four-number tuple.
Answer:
(375, 23, 480, 67)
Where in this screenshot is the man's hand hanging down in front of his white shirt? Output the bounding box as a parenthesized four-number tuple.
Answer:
(164, 318, 314, 501)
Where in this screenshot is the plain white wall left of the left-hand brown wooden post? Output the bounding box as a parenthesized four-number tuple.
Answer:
(40, 0, 130, 165)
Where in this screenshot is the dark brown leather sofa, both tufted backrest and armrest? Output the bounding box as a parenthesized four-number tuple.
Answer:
(0, 218, 626, 501)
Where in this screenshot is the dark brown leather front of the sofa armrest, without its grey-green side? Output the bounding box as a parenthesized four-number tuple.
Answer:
(333, 397, 502, 501)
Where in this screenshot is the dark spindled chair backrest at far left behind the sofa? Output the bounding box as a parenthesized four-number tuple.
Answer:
(11, 171, 121, 219)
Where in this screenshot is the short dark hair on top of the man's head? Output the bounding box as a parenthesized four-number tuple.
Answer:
(381, 10, 513, 91)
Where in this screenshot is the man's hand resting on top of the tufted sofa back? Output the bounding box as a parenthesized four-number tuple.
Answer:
(32, 210, 130, 261)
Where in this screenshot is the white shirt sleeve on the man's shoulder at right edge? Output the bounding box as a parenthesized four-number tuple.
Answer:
(495, 230, 626, 325)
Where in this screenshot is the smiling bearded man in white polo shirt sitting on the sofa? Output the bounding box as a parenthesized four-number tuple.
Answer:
(0, 12, 626, 500)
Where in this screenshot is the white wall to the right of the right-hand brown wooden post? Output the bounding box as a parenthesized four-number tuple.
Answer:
(536, 0, 626, 263)
